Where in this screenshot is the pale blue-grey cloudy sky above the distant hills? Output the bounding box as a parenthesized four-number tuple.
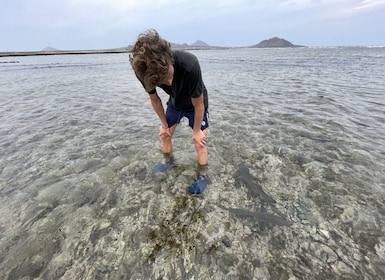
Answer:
(0, 0, 385, 51)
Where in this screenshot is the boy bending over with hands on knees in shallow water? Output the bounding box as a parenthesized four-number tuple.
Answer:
(130, 29, 209, 194)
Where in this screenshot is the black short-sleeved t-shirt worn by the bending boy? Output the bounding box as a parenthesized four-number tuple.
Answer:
(149, 51, 208, 111)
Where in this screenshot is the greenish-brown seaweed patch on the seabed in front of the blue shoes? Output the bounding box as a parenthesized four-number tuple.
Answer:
(147, 195, 204, 262)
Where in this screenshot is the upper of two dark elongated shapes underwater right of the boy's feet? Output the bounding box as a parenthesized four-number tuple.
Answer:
(236, 163, 275, 204)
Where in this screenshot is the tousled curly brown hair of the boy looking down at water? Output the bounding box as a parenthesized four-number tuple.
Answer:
(130, 29, 174, 91)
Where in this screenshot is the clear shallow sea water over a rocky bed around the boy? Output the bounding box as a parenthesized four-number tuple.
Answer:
(0, 47, 385, 280)
